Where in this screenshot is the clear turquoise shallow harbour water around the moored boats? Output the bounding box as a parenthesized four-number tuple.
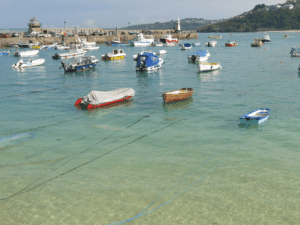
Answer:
(0, 33, 300, 225)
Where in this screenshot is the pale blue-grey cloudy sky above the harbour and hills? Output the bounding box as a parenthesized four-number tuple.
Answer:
(0, 0, 285, 28)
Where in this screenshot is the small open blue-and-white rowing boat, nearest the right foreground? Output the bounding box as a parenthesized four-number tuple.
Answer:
(240, 108, 270, 124)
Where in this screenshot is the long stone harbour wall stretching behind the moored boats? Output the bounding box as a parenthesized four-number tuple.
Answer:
(0, 31, 198, 48)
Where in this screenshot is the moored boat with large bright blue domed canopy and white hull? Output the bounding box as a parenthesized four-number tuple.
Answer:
(135, 53, 164, 71)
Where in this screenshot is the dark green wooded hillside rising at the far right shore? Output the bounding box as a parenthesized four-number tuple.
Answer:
(197, 5, 300, 32)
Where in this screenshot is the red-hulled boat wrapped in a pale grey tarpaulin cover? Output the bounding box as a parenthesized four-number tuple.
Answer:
(75, 88, 135, 109)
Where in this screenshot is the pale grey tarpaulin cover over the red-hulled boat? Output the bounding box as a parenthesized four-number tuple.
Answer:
(82, 88, 135, 105)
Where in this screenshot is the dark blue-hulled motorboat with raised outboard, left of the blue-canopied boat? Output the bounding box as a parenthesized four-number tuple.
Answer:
(59, 56, 99, 72)
